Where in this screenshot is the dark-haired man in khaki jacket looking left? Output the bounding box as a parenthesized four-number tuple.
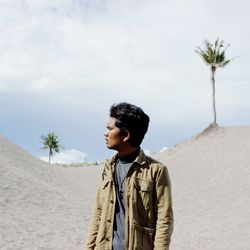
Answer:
(87, 103, 173, 250)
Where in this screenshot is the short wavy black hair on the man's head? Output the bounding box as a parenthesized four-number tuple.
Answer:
(110, 102, 149, 147)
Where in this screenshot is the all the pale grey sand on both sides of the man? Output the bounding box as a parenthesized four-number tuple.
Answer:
(0, 126, 250, 250)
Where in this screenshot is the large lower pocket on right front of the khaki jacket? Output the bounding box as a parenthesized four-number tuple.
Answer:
(132, 222, 155, 250)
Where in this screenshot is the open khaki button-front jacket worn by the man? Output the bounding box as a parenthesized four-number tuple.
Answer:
(86, 150, 173, 250)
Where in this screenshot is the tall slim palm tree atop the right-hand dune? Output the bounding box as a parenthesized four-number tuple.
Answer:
(195, 39, 234, 126)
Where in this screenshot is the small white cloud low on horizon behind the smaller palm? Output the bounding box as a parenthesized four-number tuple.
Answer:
(39, 149, 87, 164)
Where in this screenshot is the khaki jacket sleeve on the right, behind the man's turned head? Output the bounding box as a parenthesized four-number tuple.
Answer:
(154, 166, 174, 250)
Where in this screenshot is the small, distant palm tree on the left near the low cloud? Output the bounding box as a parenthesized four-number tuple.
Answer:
(41, 132, 63, 164)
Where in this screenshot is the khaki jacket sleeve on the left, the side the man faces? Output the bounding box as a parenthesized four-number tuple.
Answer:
(86, 179, 102, 250)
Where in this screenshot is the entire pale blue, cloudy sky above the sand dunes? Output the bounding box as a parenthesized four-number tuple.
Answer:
(0, 0, 250, 161)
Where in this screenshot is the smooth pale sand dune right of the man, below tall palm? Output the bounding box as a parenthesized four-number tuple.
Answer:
(157, 126, 250, 250)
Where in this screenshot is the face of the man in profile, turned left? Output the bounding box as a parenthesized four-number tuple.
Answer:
(104, 117, 124, 151)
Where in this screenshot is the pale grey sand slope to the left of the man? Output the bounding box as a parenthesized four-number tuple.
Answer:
(0, 136, 101, 250)
